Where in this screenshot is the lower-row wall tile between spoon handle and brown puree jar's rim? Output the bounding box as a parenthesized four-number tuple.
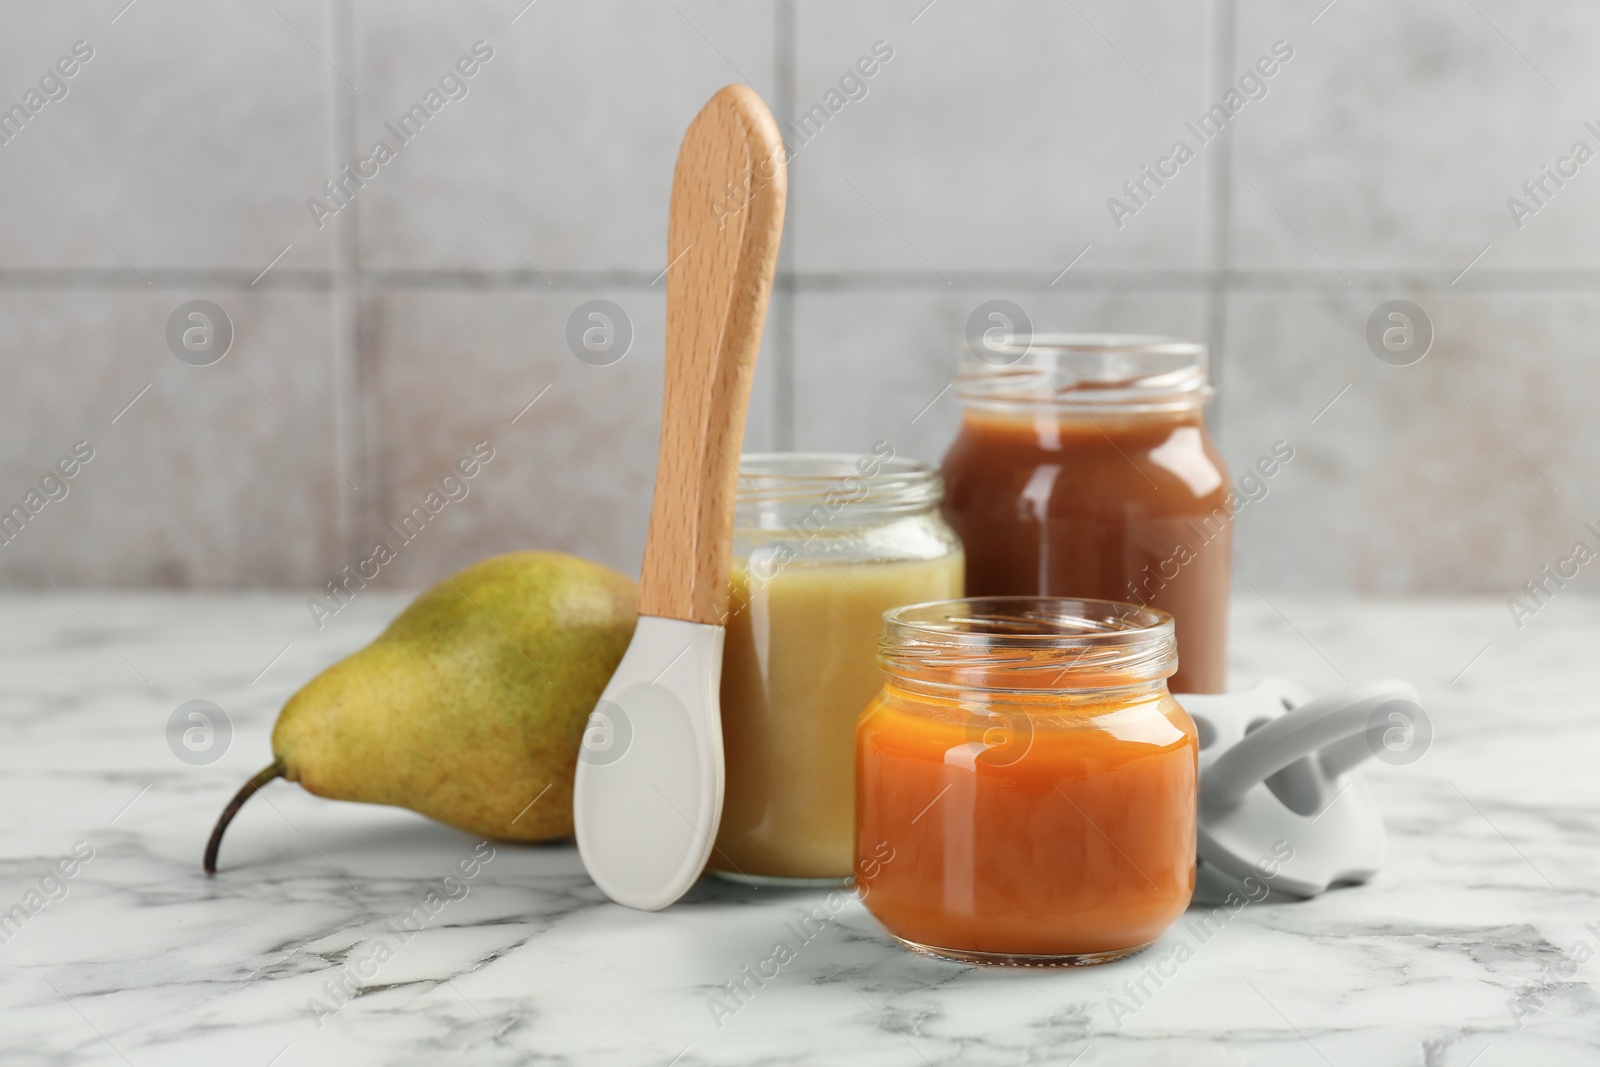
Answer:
(795, 290, 1205, 462)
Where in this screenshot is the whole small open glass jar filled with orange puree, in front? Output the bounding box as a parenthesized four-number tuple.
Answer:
(856, 597, 1200, 966)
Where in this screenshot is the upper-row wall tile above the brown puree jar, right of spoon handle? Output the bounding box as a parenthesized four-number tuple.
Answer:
(793, 0, 1211, 277)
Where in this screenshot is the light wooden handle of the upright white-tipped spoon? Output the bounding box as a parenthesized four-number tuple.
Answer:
(638, 85, 787, 625)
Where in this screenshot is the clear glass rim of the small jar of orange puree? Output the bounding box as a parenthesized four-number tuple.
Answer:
(880, 597, 1178, 691)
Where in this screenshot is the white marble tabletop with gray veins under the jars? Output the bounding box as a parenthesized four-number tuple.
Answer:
(0, 589, 1600, 1067)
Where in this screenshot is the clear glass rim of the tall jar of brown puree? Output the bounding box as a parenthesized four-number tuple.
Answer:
(955, 333, 1214, 411)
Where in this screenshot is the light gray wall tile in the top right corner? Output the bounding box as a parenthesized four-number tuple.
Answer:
(1232, 0, 1600, 275)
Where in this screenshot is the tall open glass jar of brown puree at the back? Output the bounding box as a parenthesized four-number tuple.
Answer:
(942, 334, 1238, 693)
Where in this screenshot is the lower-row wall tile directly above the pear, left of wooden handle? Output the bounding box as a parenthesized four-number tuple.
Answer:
(365, 288, 784, 585)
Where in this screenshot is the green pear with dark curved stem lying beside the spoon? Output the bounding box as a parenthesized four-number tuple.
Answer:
(205, 552, 637, 873)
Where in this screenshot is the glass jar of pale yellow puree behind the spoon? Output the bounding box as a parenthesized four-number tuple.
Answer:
(710, 442, 963, 883)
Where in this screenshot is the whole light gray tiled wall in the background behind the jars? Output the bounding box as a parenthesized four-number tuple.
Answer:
(0, 0, 1600, 595)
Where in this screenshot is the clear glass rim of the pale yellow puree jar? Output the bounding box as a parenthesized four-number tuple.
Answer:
(734, 443, 944, 526)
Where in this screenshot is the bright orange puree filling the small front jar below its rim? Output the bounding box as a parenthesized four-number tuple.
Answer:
(856, 678, 1198, 957)
